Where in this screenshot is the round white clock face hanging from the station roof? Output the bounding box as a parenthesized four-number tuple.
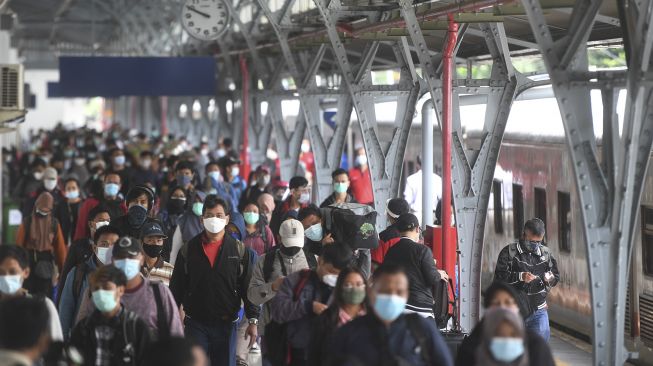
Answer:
(181, 0, 230, 41)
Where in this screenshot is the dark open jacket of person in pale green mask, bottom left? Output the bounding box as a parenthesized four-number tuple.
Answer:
(70, 308, 153, 366)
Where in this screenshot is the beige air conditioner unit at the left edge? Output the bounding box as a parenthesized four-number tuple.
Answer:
(0, 65, 26, 123)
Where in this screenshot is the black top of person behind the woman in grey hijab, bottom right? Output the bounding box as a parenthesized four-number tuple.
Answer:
(456, 320, 555, 366)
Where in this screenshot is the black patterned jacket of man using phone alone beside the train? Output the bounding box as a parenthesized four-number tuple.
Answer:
(494, 242, 560, 316)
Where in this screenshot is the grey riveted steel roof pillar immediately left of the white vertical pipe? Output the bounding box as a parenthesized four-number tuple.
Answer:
(314, 0, 420, 228)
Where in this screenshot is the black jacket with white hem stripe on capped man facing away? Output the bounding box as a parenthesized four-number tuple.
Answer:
(383, 238, 440, 312)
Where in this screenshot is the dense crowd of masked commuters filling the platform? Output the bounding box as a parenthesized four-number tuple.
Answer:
(0, 128, 559, 366)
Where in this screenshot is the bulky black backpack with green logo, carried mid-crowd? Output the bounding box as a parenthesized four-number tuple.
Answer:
(324, 203, 379, 249)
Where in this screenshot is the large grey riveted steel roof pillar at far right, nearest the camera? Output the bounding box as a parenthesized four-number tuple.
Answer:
(522, 0, 653, 365)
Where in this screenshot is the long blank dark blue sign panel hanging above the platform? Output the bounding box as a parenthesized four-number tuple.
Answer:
(48, 57, 216, 97)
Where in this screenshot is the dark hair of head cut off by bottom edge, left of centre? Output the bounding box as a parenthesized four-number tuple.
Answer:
(143, 337, 196, 366)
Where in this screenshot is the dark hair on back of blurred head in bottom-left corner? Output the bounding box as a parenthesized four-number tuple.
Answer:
(0, 296, 50, 351)
